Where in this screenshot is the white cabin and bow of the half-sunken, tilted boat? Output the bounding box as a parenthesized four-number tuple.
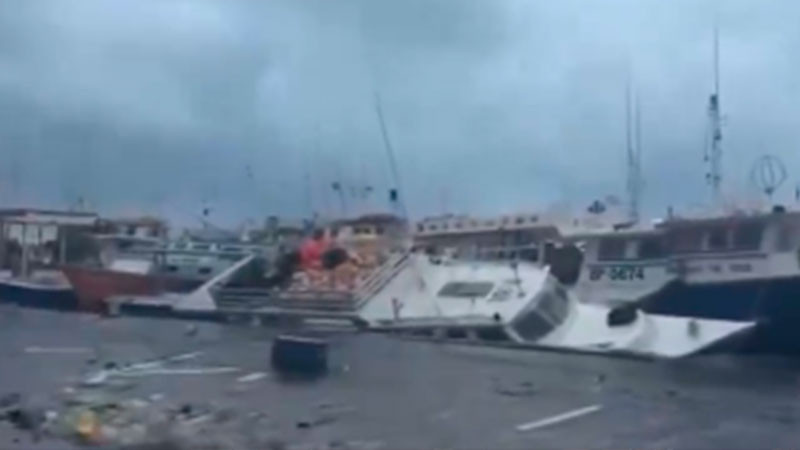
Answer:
(358, 254, 756, 358)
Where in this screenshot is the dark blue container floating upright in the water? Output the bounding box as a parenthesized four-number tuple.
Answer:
(272, 335, 328, 376)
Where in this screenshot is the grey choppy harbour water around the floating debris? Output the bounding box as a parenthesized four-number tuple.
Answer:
(0, 307, 800, 448)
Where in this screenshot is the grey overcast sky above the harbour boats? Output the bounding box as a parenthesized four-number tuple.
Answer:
(0, 0, 800, 223)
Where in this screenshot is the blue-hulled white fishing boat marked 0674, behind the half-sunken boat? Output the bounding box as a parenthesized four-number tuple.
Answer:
(575, 208, 800, 351)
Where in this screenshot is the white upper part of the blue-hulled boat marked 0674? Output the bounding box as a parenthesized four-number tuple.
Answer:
(571, 212, 800, 304)
